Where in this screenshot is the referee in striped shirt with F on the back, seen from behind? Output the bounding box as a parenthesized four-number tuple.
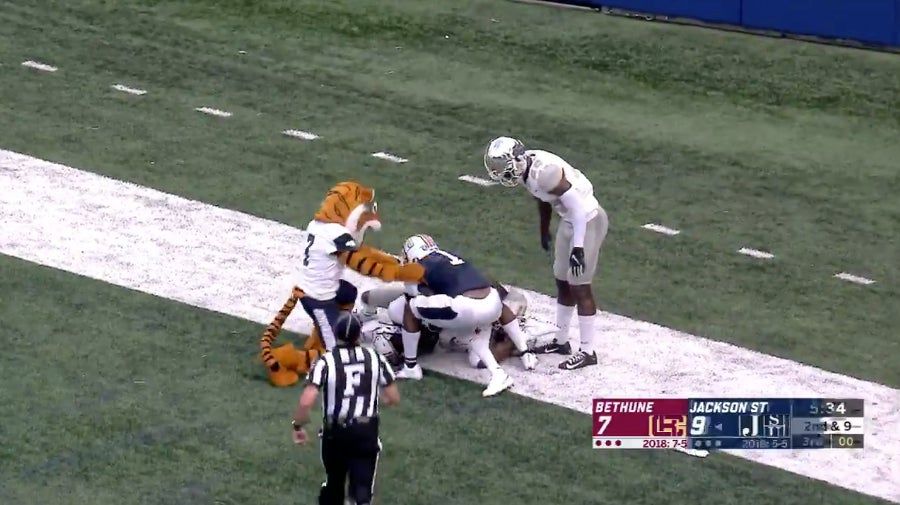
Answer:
(292, 313, 400, 505)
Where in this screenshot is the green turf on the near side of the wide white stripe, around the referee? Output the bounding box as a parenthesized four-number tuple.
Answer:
(0, 256, 877, 505)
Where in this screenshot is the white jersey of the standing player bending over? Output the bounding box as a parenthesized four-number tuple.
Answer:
(523, 149, 600, 221)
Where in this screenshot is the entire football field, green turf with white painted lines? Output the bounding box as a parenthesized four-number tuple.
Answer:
(0, 1, 900, 504)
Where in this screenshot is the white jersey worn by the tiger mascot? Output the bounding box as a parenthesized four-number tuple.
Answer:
(297, 220, 358, 300)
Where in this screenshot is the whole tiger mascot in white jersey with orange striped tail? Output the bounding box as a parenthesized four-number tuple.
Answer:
(259, 181, 424, 387)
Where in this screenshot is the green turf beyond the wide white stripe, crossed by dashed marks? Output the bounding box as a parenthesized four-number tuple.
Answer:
(0, 0, 900, 386)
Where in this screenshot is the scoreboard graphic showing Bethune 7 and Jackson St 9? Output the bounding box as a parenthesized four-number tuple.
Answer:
(592, 398, 865, 450)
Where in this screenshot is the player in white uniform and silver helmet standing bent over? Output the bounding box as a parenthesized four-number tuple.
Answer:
(484, 137, 609, 370)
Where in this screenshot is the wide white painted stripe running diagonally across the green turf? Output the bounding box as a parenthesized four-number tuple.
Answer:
(0, 150, 900, 503)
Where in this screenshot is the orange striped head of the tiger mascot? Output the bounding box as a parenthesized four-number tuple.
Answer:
(315, 181, 381, 242)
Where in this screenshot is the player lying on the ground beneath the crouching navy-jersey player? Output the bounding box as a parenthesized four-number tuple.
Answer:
(360, 282, 536, 368)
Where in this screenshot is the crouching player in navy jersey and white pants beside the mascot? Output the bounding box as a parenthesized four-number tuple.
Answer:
(397, 235, 537, 396)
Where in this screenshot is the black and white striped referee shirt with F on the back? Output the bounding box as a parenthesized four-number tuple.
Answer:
(306, 345, 394, 426)
